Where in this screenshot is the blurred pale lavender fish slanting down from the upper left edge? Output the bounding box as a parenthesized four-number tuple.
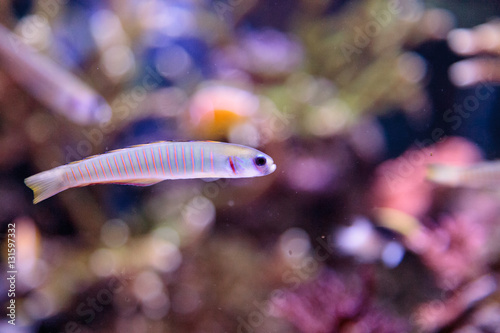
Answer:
(0, 25, 112, 125)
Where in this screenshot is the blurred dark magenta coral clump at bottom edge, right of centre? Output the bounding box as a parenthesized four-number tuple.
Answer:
(272, 270, 405, 333)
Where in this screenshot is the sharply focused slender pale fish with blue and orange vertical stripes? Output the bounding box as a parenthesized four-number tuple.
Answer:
(24, 141, 276, 204)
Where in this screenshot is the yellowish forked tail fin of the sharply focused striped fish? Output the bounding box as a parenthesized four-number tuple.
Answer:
(24, 168, 67, 204)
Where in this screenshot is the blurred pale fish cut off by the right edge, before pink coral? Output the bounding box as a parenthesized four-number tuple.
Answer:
(427, 161, 500, 188)
